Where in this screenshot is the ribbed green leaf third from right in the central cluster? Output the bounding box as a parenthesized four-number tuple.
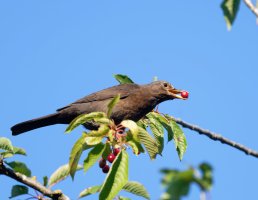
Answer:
(138, 127, 159, 159)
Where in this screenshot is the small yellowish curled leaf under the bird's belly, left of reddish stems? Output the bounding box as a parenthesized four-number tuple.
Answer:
(85, 125, 110, 145)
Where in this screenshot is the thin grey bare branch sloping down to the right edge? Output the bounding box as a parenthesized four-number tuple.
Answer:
(173, 118, 258, 158)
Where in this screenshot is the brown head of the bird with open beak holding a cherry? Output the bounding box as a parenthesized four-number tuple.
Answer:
(149, 81, 186, 101)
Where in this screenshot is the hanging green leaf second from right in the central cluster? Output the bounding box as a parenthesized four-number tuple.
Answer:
(147, 112, 164, 154)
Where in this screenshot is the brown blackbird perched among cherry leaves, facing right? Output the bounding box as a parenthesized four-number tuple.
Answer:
(11, 81, 184, 135)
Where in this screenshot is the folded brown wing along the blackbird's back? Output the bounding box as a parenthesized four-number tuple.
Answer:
(57, 83, 140, 111)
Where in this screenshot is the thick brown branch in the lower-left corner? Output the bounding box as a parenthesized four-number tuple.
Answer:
(0, 158, 70, 200)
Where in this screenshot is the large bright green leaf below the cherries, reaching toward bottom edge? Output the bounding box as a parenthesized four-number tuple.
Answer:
(99, 150, 128, 200)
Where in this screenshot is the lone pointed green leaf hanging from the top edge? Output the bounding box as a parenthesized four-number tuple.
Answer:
(221, 0, 240, 30)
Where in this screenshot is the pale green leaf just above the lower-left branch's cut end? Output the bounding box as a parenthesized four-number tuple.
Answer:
(48, 164, 82, 187)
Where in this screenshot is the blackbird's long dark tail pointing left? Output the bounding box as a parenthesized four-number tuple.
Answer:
(11, 113, 59, 135)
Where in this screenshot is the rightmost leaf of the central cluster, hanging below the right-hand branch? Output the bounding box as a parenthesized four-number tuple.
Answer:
(170, 120, 187, 160)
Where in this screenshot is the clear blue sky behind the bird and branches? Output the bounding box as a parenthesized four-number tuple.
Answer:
(0, 0, 258, 200)
